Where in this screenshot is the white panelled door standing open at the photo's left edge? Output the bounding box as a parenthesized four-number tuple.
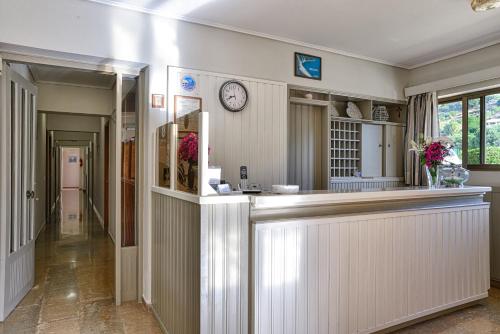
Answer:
(0, 62, 37, 321)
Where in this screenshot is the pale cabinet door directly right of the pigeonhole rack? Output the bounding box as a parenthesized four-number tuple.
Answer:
(361, 124, 384, 177)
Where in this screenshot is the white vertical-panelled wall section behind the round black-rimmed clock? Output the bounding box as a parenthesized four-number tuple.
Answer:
(168, 67, 287, 188)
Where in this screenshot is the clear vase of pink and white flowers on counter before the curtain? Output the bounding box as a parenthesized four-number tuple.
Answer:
(410, 136, 453, 188)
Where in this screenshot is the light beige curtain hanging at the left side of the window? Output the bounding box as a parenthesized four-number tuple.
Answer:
(405, 92, 439, 186)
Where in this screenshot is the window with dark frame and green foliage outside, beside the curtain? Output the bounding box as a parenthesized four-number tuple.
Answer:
(438, 90, 500, 169)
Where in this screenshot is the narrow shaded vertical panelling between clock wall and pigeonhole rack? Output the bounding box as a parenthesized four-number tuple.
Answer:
(288, 103, 328, 190)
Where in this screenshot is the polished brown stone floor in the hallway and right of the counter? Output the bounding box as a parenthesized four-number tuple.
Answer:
(8, 192, 500, 334)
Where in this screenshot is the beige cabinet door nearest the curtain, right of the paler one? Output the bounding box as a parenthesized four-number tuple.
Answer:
(384, 125, 404, 177)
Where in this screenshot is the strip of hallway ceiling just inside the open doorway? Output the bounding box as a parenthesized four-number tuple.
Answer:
(28, 65, 115, 89)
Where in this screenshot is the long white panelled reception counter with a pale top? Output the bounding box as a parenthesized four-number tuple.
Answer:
(152, 187, 491, 334)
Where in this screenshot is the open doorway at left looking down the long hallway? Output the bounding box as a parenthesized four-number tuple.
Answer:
(3, 58, 148, 328)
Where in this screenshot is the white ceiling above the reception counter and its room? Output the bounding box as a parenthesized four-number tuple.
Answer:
(91, 0, 500, 68)
